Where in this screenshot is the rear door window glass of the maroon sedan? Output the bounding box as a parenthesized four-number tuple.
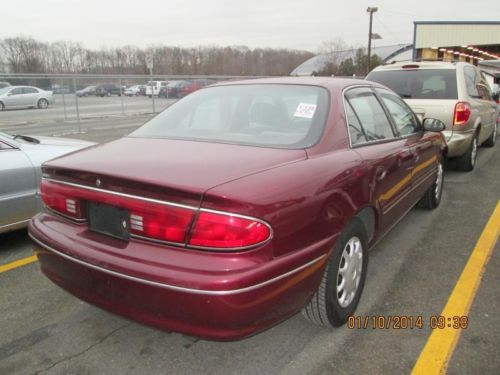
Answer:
(346, 88, 395, 144)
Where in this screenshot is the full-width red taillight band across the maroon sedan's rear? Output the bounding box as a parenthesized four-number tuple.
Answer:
(40, 179, 271, 250)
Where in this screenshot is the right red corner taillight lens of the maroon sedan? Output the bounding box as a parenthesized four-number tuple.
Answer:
(189, 212, 271, 249)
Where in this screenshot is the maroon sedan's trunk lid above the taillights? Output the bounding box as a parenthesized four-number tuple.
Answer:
(44, 137, 306, 206)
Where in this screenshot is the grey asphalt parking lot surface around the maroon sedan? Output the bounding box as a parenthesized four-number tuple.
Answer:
(0, 113, 500, 374)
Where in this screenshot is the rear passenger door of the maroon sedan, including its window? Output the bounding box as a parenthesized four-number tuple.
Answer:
(345, 87, 415, 231)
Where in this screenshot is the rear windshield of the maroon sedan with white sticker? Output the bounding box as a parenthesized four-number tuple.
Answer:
(130, 84, 328, 148)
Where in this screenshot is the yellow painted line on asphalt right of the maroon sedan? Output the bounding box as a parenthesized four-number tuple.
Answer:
(411, 201, 500, 375)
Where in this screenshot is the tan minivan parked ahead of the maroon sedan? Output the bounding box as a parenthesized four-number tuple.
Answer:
(366, 61, 498, 171)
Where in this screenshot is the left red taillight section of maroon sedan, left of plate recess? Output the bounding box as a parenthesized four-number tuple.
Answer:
(40, 180, 84, 219)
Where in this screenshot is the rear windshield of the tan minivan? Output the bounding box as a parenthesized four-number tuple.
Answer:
(366, 69, 458, 99)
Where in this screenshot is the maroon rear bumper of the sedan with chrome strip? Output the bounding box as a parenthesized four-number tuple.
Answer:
(30, 213, 332, 340)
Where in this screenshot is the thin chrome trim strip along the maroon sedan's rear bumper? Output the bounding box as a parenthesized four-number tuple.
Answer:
(29, 233, 326, 296)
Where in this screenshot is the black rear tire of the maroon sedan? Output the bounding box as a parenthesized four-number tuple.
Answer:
(302, 219, 368, 327)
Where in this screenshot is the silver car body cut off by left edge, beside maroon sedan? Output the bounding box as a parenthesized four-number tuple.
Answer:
(0, 139, 37, 231)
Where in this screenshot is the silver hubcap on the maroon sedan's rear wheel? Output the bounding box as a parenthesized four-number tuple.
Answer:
(337, 237, 363, 308)
